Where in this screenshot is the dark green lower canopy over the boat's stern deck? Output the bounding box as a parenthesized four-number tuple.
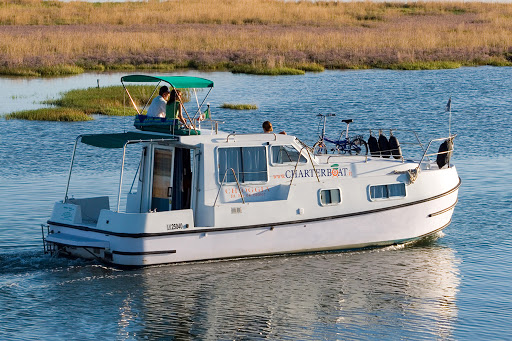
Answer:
(82, 132, 177, 148)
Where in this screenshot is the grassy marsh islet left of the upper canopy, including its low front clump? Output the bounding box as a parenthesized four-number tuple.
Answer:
(5, 86, 154, 122)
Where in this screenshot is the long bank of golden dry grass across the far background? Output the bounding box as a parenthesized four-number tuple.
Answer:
(0, 0, 512, 76)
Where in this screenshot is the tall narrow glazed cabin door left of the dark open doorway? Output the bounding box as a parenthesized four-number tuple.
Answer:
(151, 146, 174, 212)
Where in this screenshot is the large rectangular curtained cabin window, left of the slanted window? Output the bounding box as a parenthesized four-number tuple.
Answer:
(219, 146, 268, 183)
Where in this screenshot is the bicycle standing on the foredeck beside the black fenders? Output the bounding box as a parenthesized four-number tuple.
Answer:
(313, 114, 368, 155)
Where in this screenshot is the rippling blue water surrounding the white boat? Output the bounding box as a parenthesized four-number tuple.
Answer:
(0, 67, 512, 340)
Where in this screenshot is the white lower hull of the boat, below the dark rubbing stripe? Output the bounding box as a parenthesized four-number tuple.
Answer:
(47, 180, 460, 266)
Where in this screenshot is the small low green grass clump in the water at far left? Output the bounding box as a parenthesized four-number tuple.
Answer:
(5, 108, 93, 122)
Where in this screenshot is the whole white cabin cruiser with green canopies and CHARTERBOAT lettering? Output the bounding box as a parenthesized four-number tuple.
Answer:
(43, 75, 460, 266)
